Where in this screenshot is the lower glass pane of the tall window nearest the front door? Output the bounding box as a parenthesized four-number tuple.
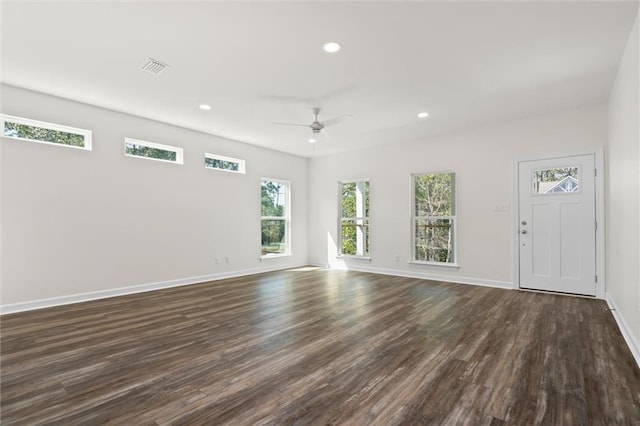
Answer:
(415, 219, 454, 263)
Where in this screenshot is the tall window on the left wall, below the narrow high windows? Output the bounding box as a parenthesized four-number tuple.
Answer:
(262, 179, 289, 257)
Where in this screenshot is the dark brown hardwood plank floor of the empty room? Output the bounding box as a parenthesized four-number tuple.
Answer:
(1, 270, 640, 425)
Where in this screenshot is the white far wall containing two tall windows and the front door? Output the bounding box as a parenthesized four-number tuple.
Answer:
(309, 105, 607, 287)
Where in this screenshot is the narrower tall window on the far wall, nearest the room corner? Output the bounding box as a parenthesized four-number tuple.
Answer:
(338, 180, 369, 256)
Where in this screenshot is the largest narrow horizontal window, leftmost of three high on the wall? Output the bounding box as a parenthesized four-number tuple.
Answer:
(0, 114, 91, 151)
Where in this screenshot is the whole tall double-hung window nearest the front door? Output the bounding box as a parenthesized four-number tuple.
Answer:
(412, 172, 456, 264)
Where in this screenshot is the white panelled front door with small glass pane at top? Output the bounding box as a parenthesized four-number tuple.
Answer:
(518, 155, 596, 296)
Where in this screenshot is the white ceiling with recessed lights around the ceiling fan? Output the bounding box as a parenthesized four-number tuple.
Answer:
(2, 1, 638, 157)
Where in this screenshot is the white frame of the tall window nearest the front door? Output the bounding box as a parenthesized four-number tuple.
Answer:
(409, 170, 459, 269)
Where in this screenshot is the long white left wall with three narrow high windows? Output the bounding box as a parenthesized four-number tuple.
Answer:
(1, 86, 308, 305)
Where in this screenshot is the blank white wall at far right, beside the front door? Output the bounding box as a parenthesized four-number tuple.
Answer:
(607, 11, 640, 352)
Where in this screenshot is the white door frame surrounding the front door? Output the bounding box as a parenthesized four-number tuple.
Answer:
(511, 148, 606, 299)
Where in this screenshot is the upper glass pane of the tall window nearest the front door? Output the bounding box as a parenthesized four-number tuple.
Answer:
(414, 173, 455, 216)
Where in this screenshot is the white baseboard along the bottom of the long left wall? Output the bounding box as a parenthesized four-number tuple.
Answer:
(0, 263, 308, 315)
